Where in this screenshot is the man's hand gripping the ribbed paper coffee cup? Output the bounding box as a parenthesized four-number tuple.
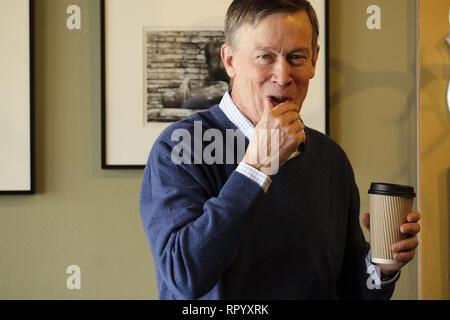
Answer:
(362, 211, 420, 275)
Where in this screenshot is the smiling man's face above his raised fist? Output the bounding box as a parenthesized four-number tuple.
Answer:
(222, 11, 319, 124)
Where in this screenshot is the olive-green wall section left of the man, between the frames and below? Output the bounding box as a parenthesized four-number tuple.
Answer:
(0, 0, 157, 299)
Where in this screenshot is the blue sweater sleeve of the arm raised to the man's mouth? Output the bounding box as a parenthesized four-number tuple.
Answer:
(140, 140, 264, 299)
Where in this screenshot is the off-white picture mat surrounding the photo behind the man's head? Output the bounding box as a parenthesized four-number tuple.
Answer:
(104, 0, 326, 166)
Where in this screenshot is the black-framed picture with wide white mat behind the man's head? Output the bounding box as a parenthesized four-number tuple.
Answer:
(101, 0, 328, 169)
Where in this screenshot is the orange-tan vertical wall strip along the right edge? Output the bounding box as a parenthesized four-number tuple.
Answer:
(419, 0, 450, 299)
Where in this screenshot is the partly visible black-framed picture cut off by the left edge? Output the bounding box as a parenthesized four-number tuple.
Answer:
(0, 0, 34, 194)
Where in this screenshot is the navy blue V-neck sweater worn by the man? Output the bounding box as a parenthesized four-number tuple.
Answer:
(141, 106, 394, 299)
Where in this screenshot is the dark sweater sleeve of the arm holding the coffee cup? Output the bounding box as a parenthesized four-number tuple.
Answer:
(338, 163, 395, 300)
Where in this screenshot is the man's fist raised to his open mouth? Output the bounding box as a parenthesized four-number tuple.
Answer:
(244, 100, 306, 176)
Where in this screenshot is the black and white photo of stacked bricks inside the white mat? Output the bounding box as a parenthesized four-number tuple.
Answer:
(145, 29, 229, 122)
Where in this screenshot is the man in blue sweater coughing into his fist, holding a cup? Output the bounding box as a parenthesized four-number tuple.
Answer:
(141, 0, 420, 299)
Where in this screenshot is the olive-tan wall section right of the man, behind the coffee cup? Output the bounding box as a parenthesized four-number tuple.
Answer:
(330, 0, 418, 299)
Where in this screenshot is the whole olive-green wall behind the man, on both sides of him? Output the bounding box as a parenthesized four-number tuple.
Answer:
(0, 0, 417, 299)
